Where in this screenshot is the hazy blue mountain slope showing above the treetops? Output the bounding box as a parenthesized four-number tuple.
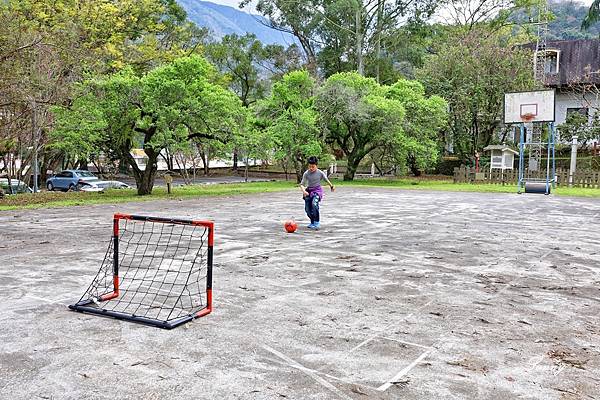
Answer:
(177, 0, 295, 47)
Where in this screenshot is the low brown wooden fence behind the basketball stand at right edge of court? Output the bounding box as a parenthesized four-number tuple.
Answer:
(454, 166, 600, 188)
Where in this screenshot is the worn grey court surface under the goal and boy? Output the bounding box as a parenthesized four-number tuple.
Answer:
(0, 187, 600, 399)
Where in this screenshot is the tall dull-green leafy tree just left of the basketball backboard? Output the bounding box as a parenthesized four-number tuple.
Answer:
(417, 28, 535, 160)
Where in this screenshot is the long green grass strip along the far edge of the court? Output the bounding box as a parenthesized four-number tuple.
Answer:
(0, 178, 600, 211)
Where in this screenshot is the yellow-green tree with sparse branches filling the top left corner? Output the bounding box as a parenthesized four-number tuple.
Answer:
(0, 0, 205, 187)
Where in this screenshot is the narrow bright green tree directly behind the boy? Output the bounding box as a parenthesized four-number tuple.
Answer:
(257, 71, 323, 183)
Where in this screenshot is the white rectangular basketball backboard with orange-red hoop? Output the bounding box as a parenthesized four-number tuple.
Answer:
(504, 89, 555, 124)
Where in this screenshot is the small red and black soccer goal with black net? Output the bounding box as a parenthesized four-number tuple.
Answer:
(69, 214, 214, 329)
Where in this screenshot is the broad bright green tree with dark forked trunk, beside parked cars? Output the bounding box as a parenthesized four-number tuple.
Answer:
(54, 56, 245, 195)
